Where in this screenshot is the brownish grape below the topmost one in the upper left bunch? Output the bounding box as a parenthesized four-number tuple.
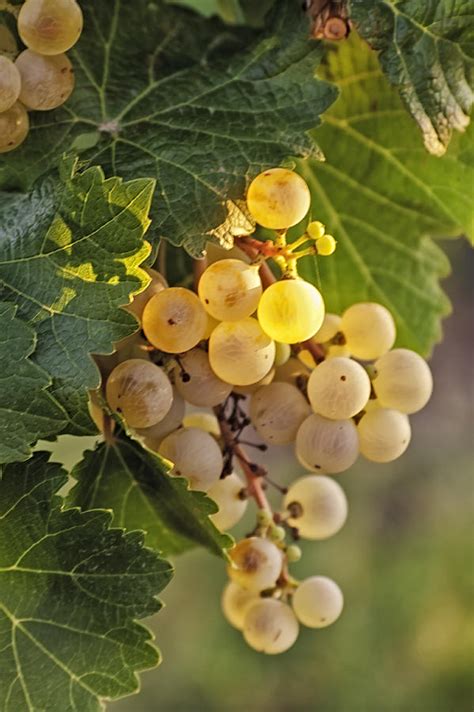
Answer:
(15, 49, 75, 111)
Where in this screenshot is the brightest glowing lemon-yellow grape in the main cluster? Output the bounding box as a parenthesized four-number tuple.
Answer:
(257, 279, 324, 344)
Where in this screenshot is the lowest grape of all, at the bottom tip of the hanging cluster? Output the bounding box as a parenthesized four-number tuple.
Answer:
(243, 598, 299, 655)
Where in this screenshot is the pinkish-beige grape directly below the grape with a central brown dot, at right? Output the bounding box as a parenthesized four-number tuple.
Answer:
(295, 414, 359, 474)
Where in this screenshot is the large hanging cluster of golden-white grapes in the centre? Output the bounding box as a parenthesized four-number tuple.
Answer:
(91, 168, 432, 654)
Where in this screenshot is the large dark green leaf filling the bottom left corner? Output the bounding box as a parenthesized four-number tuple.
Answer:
(0, 453, 172, 712)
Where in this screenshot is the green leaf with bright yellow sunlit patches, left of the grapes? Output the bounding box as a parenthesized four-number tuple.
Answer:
(0, 161, 154, 435)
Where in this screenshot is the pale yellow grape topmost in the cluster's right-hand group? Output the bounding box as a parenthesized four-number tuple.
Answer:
(341, 302, 396, 360)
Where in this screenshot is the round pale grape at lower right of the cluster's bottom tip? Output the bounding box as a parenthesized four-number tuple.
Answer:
(292, 576, 344, 628)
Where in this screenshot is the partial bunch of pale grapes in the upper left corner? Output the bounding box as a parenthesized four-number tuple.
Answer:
(0, 0, 83, 153)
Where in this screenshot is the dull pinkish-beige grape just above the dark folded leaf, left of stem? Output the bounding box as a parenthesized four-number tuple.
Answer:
(159, 428, 224, 492)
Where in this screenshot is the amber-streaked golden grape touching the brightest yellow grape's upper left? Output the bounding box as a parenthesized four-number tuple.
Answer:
(198, 259, 262, 321)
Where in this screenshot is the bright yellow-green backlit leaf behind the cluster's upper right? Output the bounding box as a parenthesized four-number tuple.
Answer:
(298, 36, 474, 354)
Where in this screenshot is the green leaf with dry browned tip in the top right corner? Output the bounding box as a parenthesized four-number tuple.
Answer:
(351, 0, 474, 156)
